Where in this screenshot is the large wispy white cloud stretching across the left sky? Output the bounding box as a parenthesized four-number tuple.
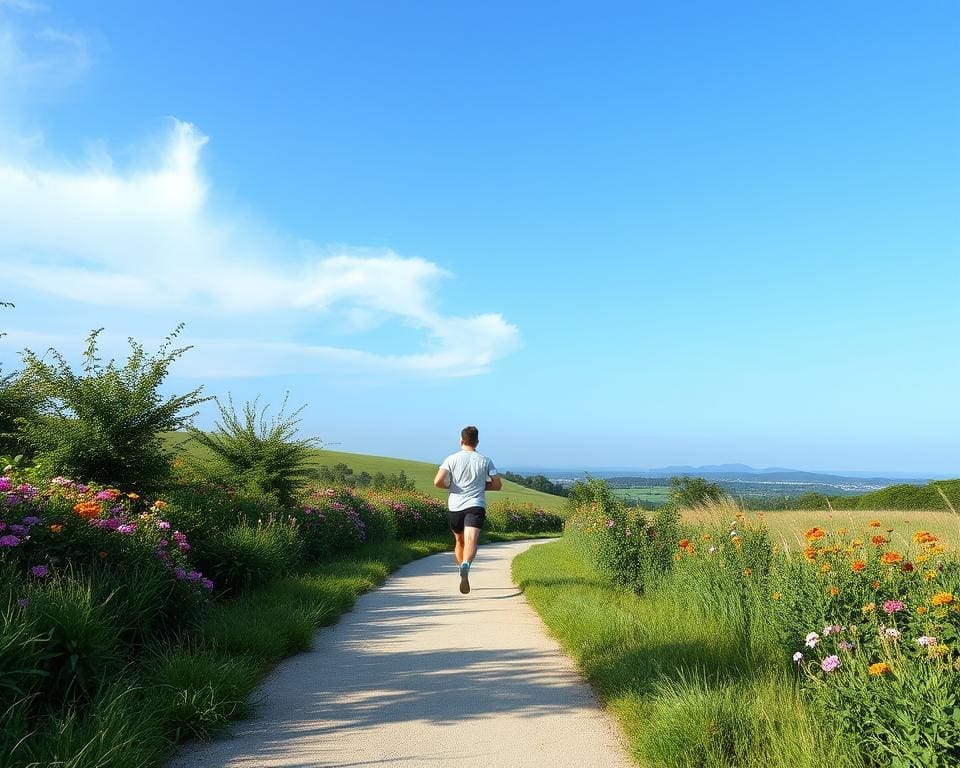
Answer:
(0, 120, 519, 376)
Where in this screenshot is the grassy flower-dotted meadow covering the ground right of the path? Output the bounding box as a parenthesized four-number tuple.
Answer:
(514, 481, 960, 768)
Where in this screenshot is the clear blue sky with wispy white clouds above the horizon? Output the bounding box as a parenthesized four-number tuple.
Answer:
(0, 0, 960, 475)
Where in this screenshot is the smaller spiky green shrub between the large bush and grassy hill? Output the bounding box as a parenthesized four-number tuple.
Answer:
(190, 397, 319, 506)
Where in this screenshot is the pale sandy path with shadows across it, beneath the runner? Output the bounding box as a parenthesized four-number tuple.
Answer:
(170, 541, 632, 768)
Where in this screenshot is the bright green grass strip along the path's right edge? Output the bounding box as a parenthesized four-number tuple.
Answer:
(513, 539, 855, 768)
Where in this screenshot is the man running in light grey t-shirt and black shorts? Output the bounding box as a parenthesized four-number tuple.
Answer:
(433, 427, 502, 595)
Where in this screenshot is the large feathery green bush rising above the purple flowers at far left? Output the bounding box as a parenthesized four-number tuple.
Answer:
(18, 325, 206, 493)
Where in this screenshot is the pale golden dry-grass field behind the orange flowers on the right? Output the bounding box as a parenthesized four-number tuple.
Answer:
(683, 510, 960, 550)
